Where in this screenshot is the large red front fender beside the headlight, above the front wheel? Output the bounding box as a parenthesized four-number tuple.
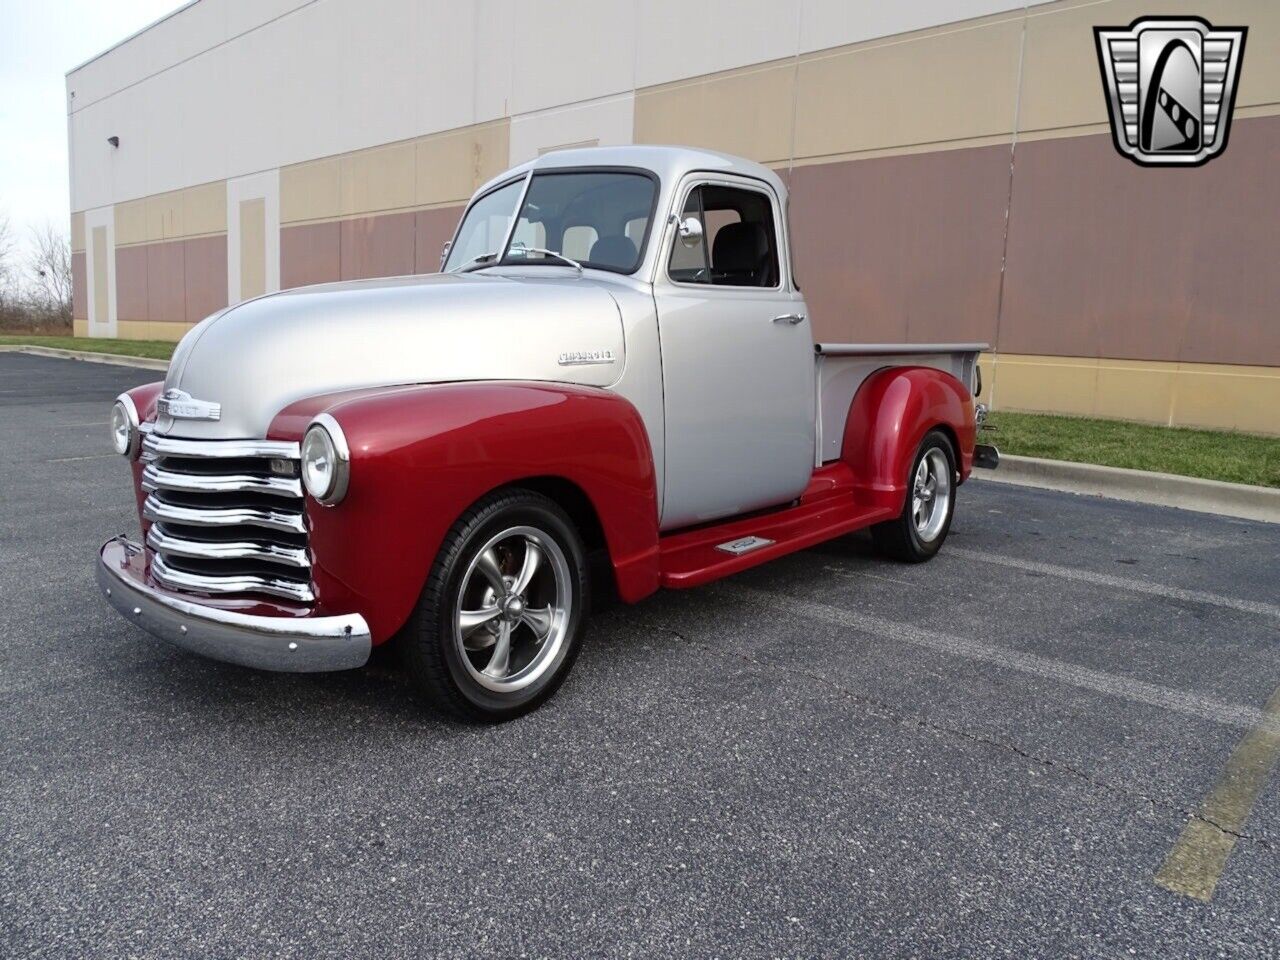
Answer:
(269, 383, 658, 643)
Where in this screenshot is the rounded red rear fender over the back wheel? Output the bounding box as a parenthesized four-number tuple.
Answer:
(841, 366, 977, 515)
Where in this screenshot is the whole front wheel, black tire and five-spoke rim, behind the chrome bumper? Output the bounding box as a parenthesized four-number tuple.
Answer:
(404, 490, 588, 722)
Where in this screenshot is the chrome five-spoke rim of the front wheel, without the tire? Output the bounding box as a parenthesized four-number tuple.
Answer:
(454, 526, 572, 692)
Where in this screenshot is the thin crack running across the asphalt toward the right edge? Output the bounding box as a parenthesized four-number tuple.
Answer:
(650, 621, 1280, 850)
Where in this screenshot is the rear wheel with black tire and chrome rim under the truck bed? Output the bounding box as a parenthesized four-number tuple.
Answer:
(872, 430, 956, 563)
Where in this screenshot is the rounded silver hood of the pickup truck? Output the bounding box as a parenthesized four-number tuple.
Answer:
(156, 274, 625, 439)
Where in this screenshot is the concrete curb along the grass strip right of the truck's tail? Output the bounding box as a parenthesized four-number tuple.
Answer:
(974, 454, 1280, 524)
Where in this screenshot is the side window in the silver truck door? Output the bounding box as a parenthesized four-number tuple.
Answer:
(668, 183, 778, 287)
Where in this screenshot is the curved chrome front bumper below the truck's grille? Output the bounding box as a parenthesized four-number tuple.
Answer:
(97, 536, 371, 673)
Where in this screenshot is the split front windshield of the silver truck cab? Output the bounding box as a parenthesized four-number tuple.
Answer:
(444, 170, 658, 273)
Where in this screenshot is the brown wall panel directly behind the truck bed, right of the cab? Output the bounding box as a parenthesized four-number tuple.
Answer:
(790, 146, 1009, 343)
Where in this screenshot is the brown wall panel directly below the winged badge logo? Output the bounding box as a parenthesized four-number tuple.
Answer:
(998, 116, 1280, 365)
